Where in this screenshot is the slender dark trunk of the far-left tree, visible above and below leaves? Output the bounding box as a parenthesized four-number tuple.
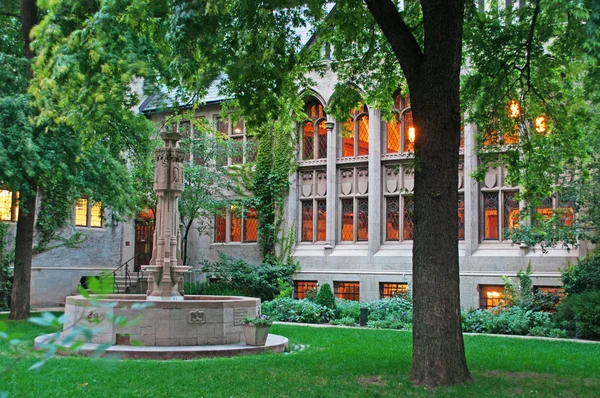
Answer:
(9, 0, 37, 319)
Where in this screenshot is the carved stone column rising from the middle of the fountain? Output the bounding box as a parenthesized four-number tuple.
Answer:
(142, 131, 191, 301)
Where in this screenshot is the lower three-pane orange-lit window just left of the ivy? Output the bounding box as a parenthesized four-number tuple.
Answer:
(214, 206, 258, 243)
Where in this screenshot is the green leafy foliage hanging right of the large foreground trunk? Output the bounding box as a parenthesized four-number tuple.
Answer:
(461, 0, 600, 250)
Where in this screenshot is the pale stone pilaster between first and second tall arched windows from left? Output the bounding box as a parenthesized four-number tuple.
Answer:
(325, 115, 337, 251)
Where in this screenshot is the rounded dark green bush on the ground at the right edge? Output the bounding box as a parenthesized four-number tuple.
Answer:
(555, 290, 600, 339)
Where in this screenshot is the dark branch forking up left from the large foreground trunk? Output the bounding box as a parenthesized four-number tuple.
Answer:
(365, 0, 423, 80)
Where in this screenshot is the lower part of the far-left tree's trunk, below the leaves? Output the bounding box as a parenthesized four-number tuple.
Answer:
(9, 194, 36, 319)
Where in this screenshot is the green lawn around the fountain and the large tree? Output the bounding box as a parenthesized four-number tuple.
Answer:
(0, 322, 600, 397)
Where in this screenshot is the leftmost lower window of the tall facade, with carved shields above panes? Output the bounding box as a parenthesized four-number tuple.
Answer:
(299, 169, 327, 242)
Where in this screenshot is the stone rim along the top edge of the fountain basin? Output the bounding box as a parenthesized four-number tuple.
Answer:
(66, 294, 260, 309)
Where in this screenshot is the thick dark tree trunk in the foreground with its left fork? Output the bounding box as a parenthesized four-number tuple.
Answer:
(365, 0, 472, 387)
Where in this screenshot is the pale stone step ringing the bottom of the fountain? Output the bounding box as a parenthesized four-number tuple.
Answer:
(34, 334, 288, 360)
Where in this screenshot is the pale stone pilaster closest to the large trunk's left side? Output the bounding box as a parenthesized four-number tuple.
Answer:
(369, 108, 381, 255)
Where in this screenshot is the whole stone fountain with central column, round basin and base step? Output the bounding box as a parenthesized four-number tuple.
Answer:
(36, 131, 288, 359)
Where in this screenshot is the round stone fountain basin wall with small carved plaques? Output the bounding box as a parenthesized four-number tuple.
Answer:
(63, 294, 260, 347)
